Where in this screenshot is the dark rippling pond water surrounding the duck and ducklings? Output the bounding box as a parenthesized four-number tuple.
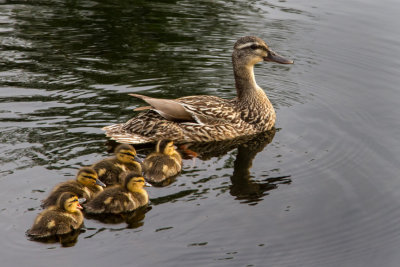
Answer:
(0, 0, 400, 267)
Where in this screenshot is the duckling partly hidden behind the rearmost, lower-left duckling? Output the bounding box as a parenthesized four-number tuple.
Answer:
(42, 167, 106, 208)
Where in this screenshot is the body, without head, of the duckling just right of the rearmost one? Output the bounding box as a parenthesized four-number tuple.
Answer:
(84, 185, 148, 214)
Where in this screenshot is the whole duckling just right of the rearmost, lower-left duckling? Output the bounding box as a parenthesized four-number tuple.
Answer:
(84, 172, 151, 214)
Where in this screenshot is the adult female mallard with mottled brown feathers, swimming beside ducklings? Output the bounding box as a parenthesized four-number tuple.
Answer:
(103, 36, 293, 144)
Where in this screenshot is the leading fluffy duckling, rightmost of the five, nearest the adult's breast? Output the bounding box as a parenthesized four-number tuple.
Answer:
(143, 140, 182, 183)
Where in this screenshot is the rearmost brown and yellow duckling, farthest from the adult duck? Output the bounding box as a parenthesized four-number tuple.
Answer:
(27, 192, 84, 239)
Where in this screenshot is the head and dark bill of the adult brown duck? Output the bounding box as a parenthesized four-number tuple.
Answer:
(232, 36, 293, 66)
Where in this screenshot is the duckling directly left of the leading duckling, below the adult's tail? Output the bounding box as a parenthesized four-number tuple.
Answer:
(92, 144, 142, 186)
